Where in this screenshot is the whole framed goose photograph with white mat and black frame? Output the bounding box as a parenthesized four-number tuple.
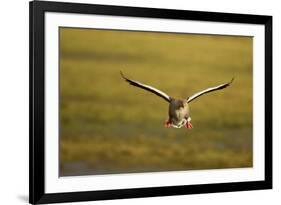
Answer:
(29, 1, 272, 204)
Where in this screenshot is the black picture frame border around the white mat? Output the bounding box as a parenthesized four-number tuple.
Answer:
(29, 1, 272, 204)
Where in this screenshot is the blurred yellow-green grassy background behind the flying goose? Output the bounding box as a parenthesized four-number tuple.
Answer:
(59, 28, 253, 176)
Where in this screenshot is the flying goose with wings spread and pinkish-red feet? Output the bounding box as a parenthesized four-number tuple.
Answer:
(120, 71, 234, 129)
